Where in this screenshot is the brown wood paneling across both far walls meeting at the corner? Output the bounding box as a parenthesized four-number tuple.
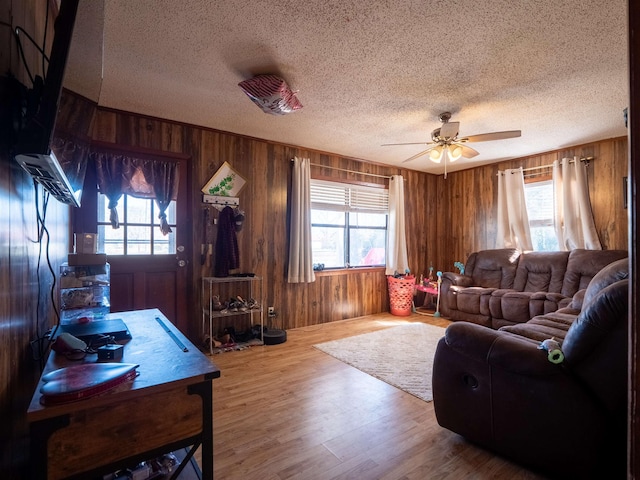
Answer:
(87, 109, 627, 334)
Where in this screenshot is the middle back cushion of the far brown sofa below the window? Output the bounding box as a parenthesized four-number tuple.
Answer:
(513, 252, 569, 293)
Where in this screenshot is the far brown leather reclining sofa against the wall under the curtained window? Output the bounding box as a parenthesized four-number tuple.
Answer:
(441, 248, 628, 329)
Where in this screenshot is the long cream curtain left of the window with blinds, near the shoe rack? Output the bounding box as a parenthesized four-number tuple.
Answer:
(287, 157, 316, 283)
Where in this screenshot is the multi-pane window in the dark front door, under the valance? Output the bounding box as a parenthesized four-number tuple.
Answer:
(98, 195, 176, 255)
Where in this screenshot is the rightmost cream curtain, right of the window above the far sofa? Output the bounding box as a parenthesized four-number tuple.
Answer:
(553, 157, 602, 250)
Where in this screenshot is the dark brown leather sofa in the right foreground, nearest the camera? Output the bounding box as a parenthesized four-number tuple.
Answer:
(433, 257, 629, 479)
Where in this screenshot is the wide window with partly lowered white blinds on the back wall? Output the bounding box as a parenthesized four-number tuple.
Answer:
(311, 179, 389, 268)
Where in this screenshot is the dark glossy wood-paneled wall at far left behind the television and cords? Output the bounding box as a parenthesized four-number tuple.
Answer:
(0, 0, 95, 472)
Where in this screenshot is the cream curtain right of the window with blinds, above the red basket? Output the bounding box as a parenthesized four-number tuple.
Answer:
(386, 175, 409, 275)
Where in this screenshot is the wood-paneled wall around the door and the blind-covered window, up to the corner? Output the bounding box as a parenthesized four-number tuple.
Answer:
(93, 109, 437, 333)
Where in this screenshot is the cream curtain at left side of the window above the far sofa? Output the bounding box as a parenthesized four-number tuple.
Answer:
(496, 167, 533, 251)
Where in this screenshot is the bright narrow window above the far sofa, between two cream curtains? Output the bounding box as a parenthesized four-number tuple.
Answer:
(524, 180, 560, 252)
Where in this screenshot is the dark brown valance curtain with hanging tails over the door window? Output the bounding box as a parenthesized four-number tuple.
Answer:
(90, 151, 180, 235)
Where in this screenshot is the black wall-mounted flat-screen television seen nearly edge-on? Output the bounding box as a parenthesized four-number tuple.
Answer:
(14, 0, 87, 207)
